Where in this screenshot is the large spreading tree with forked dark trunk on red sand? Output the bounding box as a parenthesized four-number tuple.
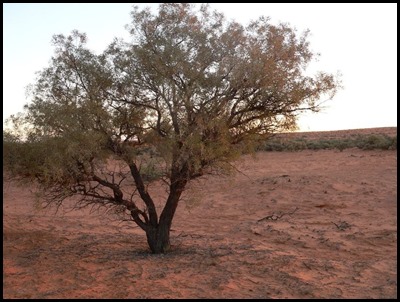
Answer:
(5, 3, 339, 253)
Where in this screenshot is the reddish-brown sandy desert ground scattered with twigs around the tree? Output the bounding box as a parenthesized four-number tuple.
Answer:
(3, 128, 397, 298)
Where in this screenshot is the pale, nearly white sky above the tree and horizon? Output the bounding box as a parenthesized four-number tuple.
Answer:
(3, 3, 397, 131)
